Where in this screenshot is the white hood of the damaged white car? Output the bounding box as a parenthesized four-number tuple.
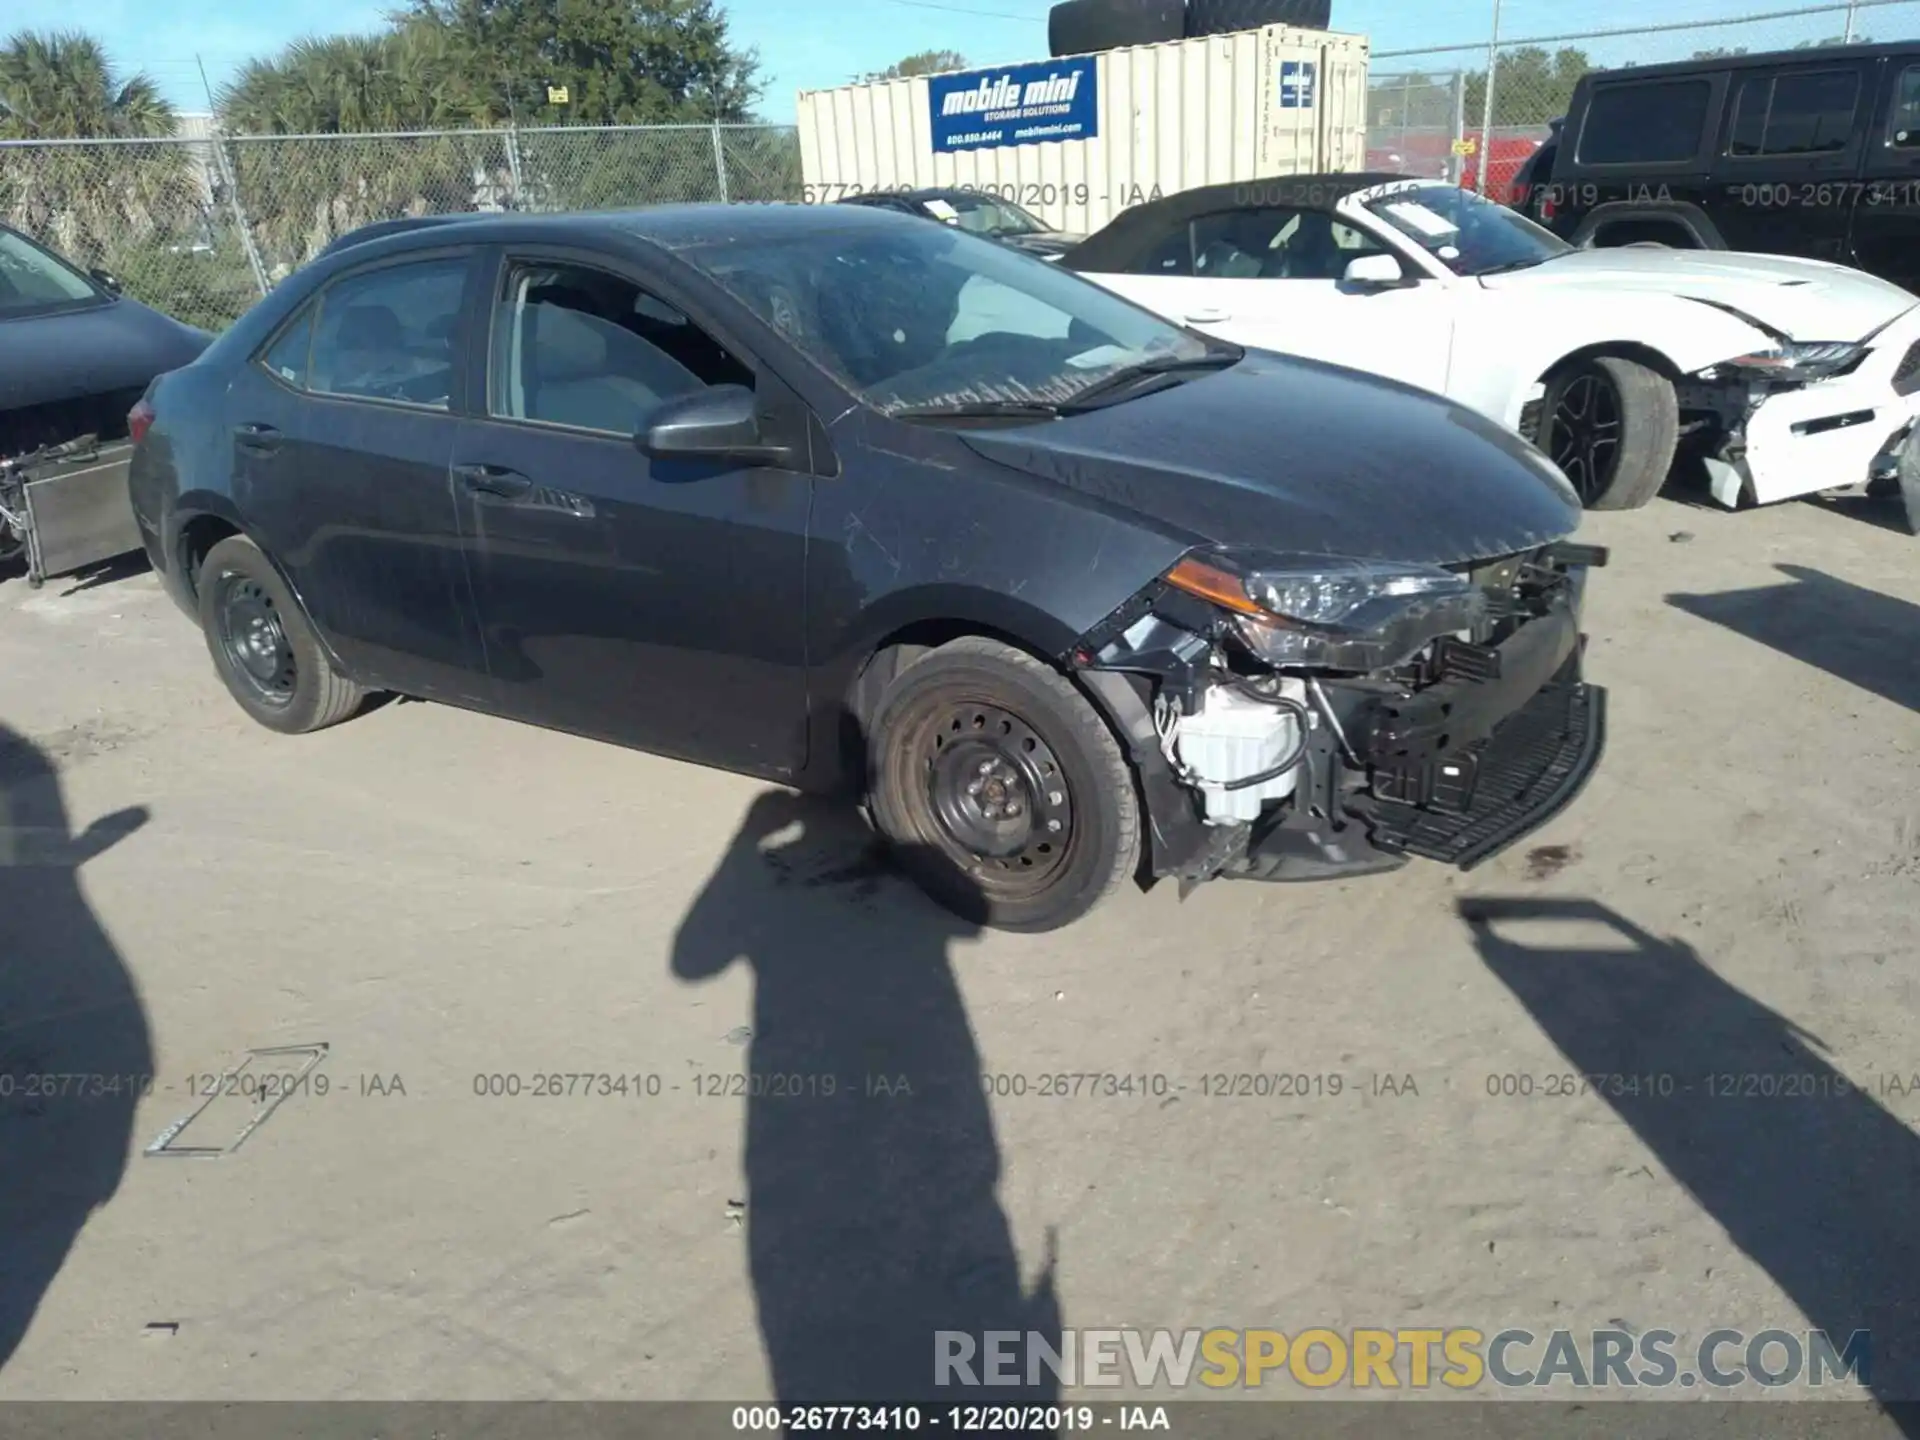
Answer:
(1480, 246, 1916, 340)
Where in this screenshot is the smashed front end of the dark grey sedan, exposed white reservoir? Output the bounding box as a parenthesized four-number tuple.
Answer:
(1062, 541, 1607, 895)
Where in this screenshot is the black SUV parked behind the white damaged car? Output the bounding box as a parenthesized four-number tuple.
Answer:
(1517, 40, 1920, 290)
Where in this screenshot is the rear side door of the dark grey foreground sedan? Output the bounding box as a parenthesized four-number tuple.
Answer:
(227, 250, 490, 705)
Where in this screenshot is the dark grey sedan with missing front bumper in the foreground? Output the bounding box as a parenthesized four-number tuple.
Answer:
(132, 205, 1605, 929)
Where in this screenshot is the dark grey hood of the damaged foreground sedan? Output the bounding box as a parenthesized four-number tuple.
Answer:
(962, 351, 1580, 564)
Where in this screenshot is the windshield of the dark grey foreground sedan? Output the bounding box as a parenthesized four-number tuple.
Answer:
(698, 225, 1233, 413)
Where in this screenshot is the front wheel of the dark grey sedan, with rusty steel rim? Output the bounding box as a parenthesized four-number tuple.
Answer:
(868, 636, 1140, 933)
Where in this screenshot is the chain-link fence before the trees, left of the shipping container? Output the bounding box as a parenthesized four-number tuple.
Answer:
(0, 125, 801, 330)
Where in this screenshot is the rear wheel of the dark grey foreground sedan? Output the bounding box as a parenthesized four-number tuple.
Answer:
(196, 536, 367, 735)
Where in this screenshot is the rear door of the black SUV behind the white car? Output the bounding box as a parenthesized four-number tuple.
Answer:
(1713, 60, 1880, 261)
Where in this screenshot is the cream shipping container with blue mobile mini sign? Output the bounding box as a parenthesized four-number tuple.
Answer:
(799, 25, 1367, 234)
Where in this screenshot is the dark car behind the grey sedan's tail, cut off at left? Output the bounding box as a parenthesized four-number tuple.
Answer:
(0, 225, 211, 584)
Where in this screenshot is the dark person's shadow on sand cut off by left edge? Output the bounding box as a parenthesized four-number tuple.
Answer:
(0, 726, 154, 1367)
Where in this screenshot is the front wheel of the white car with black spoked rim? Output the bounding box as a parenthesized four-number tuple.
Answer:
(1538, 355, 1680, 511)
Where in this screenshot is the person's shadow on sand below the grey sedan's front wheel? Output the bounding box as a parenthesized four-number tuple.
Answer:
(672, 791, 1060, 1405)
